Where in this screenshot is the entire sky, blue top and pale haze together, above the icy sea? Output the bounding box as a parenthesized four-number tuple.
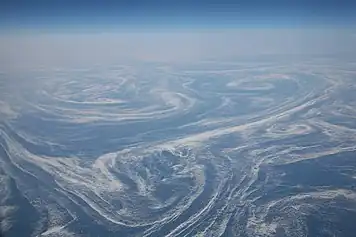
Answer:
(0, 0, 356, 69)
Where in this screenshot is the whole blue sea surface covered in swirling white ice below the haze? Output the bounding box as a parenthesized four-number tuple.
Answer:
(0, 57, 356, 237)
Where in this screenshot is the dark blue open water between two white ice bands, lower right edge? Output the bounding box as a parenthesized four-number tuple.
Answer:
(249, 152, 356, 205)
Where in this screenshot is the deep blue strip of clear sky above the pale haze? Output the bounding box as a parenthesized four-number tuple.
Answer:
(0, 0, 356, 29)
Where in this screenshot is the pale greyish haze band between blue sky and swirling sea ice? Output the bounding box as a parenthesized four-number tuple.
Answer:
(0, 28, 356, 69)
